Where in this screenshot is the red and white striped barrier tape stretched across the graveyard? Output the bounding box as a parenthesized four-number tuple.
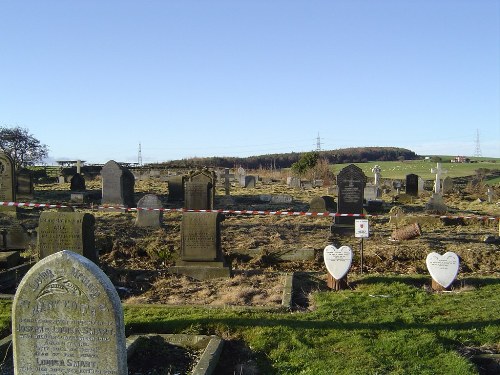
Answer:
(0, 202, 500, 220)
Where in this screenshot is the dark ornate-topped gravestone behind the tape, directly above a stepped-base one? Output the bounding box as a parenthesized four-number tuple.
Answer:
(184, 169, 216, 210)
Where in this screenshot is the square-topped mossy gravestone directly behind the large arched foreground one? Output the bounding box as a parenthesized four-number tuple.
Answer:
(37, 211, 97, 263)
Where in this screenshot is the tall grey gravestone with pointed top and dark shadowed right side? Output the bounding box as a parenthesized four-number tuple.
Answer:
(101, 160, 135, 207)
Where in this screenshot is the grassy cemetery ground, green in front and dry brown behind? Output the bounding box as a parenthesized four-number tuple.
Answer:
(0, 162, 500, 374)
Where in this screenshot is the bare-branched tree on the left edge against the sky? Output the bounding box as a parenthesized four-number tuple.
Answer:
(0, 126, 49, 170)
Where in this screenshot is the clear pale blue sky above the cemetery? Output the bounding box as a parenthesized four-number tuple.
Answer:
(0, 0, 500, 163)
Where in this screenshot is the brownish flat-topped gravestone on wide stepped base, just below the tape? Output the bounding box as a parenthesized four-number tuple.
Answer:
(170, 212, 231, 280)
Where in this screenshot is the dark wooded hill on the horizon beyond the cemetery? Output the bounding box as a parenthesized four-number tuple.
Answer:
(155, 147, 419, 169)
